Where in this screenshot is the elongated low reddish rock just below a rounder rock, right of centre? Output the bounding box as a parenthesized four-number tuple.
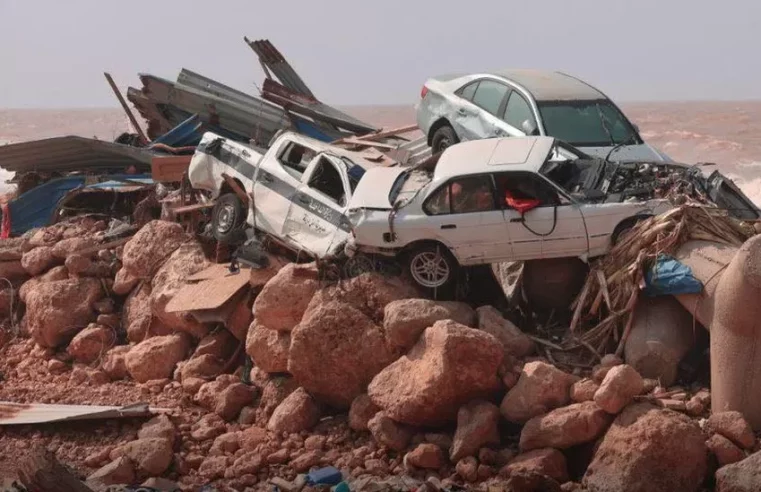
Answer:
(520, 401, 613, 451)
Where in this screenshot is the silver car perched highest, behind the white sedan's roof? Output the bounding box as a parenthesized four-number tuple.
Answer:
(416, 70, 672, 162)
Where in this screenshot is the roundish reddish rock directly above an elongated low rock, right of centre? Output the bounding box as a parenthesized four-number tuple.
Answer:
(500, 361, 578, 424)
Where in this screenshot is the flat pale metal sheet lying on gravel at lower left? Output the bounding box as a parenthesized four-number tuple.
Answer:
(0, 401, 156, 425)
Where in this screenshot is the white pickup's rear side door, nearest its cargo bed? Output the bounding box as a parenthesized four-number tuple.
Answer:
(253, 140, 315, 237)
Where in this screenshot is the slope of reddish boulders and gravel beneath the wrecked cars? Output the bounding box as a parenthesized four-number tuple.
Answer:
(0, 218, 761, 491)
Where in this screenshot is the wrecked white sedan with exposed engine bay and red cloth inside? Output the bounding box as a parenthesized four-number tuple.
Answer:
(346, 137, 672, 289)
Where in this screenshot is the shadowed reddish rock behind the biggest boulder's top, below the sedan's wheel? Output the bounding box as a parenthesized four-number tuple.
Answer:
(306, 273, 420, 324)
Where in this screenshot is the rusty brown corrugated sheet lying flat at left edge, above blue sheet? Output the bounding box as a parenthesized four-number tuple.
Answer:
(0, 136, 153, 172)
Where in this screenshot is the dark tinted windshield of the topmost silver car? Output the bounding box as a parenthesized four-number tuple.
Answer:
(538, 100, 640, 147)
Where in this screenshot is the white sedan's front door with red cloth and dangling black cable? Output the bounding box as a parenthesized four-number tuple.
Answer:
(495, 171, 589, 260)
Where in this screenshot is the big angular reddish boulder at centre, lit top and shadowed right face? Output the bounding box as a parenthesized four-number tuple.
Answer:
(370, 320, 504, 426)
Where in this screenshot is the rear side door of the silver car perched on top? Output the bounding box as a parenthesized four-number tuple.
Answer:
(451, 79, 510, 140)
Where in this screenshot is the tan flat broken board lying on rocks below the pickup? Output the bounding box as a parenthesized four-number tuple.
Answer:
(166, 265, 251, 313)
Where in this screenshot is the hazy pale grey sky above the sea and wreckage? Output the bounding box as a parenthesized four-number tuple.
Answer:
(0, 0, 761, 108)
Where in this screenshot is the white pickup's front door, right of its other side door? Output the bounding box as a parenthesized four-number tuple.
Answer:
(283, 154, 351, 257)
